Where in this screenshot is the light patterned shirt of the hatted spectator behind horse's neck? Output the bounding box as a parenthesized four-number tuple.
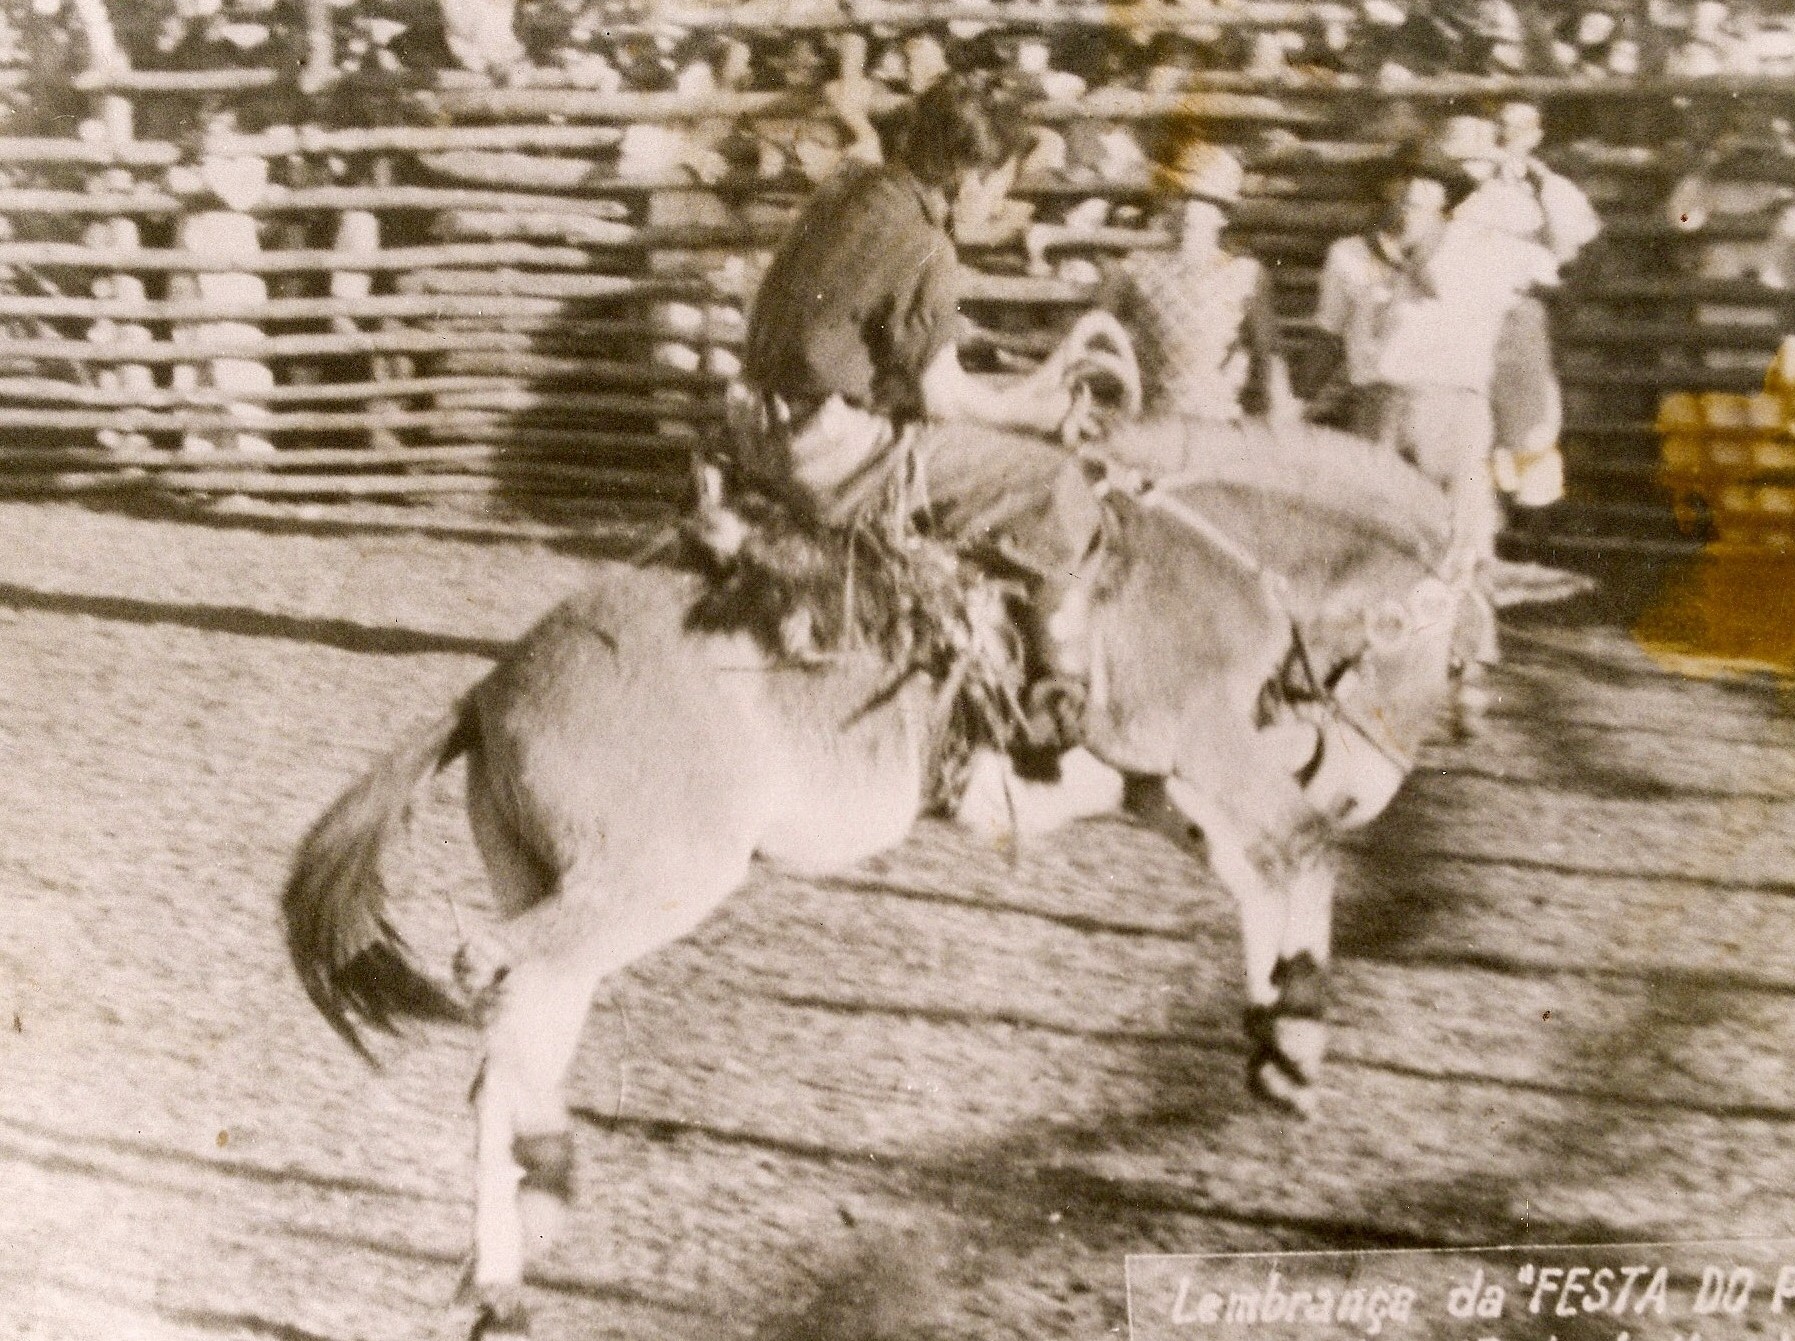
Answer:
(1122, 251, 1260, 422)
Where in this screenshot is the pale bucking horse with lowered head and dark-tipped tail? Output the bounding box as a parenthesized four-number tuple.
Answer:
(284, 369, 1468, 1337)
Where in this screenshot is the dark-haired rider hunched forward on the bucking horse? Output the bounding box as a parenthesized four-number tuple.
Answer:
(731, 74, 1095, 761)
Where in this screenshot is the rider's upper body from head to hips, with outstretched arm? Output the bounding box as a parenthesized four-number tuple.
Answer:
(738, 74, 1075, 522)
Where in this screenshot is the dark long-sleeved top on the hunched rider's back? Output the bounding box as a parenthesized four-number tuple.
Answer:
(743, 165, 959, 422)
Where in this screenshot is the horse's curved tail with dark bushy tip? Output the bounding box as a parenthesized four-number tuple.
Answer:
(282, 704, 474, 1061)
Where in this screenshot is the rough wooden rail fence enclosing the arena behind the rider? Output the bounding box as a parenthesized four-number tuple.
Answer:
(0, 0, 1795, 537)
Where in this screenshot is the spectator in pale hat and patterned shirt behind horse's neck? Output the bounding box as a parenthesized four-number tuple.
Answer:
(1104, 140, 1296, 422)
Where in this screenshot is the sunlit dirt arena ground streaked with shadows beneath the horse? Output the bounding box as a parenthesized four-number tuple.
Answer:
(0, 504, 1795, 1341)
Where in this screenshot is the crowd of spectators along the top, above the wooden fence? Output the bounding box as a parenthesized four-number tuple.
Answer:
(10, 0, 1795, 92)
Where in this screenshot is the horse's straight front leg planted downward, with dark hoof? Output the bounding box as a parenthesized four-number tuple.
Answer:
(1165, 777, 1334, 1117)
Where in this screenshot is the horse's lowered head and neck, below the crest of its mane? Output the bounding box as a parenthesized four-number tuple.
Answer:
(1054, 445, 1468, 824)
